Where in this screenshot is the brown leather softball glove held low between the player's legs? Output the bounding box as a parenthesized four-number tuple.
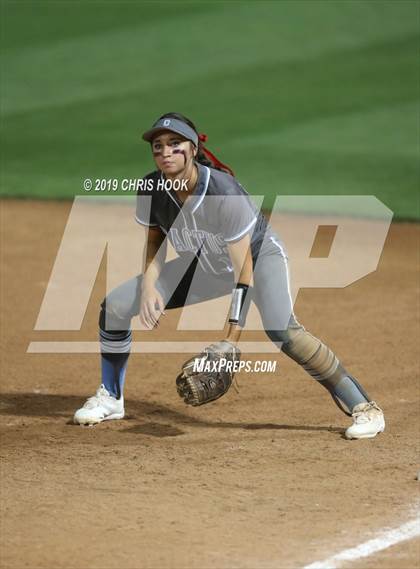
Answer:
(176, 340, 241, 406)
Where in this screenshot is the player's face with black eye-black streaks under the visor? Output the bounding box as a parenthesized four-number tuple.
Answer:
(152, 131, 196, 177)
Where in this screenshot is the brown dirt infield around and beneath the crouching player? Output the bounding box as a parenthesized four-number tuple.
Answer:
(0, 200, 420, 569)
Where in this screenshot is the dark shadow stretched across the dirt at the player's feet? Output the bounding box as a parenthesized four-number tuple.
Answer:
(0, 393, 343, 437)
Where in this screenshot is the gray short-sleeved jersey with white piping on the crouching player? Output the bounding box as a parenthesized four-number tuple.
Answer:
(136, 163, 274, 274)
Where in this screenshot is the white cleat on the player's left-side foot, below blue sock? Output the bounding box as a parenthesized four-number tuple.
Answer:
(73, 385, 124, 425)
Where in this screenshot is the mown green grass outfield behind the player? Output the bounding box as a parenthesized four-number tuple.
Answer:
(0, 0, 420, 219)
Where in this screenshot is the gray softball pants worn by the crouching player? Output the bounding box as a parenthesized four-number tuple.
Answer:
(100, 233, 301, 340)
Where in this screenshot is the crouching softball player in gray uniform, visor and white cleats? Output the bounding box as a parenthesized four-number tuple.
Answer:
(74, 113, 385, 439)
